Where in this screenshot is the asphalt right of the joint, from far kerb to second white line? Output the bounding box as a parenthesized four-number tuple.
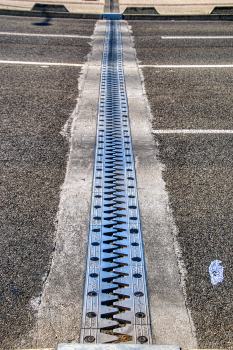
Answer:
(129, 21, 233, 64)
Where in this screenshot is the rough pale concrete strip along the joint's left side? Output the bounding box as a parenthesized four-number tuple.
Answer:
(18, 21, 105, 348)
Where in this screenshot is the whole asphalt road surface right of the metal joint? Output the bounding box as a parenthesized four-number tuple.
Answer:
(129, 21, 233, 348)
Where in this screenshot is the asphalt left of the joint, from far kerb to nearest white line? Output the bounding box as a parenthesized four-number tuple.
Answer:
(0, 17, 95, 63)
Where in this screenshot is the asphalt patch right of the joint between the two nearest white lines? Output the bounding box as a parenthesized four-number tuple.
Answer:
(147, 67, 233, 130)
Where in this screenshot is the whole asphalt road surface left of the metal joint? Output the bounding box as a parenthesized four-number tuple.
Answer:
(0, 16, 95, 349)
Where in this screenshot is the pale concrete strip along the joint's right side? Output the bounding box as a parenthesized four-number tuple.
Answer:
(121, 21, 197, 348)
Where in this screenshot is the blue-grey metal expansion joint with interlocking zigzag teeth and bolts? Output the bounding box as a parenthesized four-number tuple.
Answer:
(80, 21, 151, 344)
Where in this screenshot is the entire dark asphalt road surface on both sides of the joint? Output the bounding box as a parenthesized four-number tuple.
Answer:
(0, 16, 233, 349)
